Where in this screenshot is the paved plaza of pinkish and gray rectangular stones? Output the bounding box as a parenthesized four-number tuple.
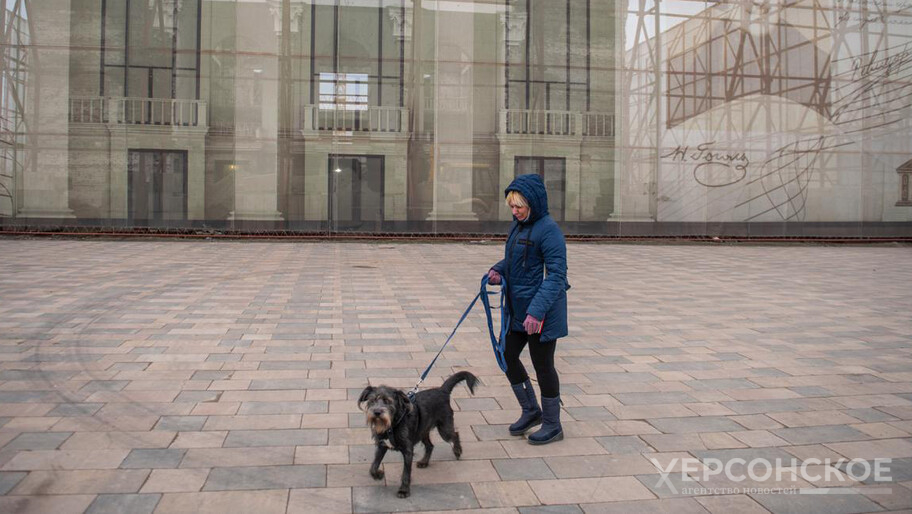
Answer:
(0, 238, 912, 514)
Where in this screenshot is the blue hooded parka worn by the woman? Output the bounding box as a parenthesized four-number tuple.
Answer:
(491, 174, 570, 341)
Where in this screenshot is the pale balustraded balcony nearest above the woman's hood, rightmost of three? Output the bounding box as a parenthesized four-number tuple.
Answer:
(498, 109, 614, 139)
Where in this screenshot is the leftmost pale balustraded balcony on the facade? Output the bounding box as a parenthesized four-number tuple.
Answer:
(69, 97, 207, 128)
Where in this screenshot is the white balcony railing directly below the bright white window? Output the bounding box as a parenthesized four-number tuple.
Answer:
(304, 105, 408, 133)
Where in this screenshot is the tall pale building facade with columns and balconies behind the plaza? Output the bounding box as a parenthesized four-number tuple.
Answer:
(0, 0, 912, 236)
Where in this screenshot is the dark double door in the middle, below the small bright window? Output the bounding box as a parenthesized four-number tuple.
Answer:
(328, 155, 383, 232)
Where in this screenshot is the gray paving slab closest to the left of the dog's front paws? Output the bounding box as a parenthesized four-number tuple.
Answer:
(203, 465, 326, 491)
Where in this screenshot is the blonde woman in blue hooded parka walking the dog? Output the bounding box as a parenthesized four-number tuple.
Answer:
(488, 175, 570, 444)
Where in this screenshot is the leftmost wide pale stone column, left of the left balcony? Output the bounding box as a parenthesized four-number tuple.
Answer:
(16, 0, 74, 219)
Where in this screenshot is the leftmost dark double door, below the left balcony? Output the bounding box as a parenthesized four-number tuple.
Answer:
(127, 150, 187, 221)
